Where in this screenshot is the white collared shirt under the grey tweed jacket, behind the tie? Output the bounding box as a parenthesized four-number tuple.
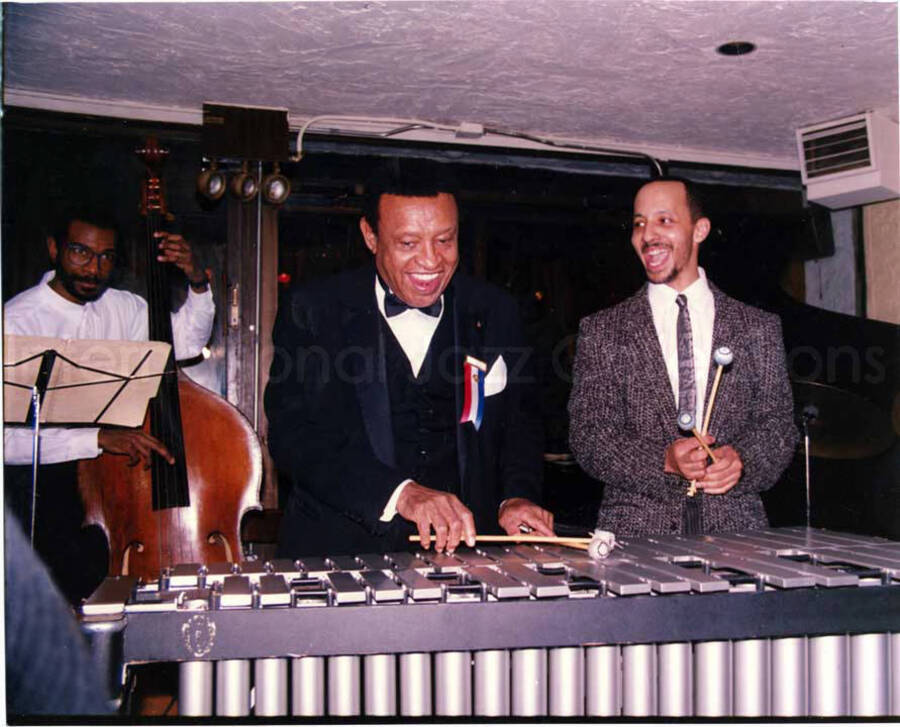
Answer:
(647, 268, 716, 429)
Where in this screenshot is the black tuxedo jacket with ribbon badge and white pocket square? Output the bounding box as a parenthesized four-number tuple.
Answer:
(265, 266, 543, 556)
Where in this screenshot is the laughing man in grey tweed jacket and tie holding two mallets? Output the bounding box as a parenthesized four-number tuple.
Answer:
(569, 177, 797, 536)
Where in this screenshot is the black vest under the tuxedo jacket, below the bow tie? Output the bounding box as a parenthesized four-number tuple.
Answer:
(381, 308, 460, 494)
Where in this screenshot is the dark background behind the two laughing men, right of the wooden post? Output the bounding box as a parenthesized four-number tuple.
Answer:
(279, 154, 900, 538)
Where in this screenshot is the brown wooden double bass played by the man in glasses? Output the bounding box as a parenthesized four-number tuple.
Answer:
(78, 138, 263, 580)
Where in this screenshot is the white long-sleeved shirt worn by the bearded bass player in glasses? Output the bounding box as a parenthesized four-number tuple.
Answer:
(3, 270, 216, 464)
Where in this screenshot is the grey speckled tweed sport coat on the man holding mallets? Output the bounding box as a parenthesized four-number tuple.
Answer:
(569, 284, 798, 536)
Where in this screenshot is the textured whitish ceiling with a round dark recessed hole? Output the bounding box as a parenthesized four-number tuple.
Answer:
(3, 0, 898, 169)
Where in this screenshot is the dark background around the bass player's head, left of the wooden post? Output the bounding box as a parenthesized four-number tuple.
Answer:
(3, 110, 225, 301)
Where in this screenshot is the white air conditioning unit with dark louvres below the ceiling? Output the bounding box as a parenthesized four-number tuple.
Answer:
(797, 112, 900, 209)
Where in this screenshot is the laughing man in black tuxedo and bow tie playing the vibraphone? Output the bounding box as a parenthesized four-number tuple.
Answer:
(265, 164, 553, 556)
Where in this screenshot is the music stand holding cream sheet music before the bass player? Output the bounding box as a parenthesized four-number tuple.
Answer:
(3, 335, 171, 545)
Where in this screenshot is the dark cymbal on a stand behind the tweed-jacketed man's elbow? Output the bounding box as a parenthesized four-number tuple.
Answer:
(791, 381, 895, 459)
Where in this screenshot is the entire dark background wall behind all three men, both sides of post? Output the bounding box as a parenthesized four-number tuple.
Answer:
(2, 110, 900, 537)
